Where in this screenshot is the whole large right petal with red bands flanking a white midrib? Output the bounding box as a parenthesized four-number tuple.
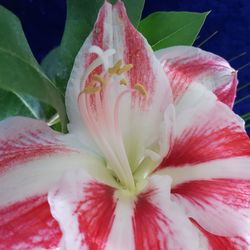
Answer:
(156, 84, 250, 241)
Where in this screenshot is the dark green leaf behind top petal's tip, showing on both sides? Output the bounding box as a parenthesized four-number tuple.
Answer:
(42, 0, 144, 93)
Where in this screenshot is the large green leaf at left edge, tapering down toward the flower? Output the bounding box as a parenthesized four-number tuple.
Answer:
(0, 6, 66, 129)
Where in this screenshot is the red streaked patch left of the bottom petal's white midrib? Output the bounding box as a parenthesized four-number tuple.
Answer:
(75, 182, 116, 250)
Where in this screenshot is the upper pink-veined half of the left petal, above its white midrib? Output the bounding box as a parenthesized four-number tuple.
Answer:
(0, 117, 70, 170)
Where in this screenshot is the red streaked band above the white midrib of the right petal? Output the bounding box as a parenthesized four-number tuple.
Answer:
(158, 126, 250, 169)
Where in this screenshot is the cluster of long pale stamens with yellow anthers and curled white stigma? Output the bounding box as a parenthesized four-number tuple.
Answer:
(78, 47, 152, 192)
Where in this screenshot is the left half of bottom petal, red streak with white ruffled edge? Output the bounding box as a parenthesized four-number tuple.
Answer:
(49, 170, 116, 249)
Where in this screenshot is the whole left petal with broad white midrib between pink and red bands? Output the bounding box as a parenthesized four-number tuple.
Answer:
(0, 118, 109, 249)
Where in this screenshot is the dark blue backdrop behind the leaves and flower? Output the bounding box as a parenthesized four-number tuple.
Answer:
(0, 0, 250, 131)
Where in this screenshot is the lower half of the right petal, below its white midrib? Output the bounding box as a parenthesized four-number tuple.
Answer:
(171, 178, 250, 241)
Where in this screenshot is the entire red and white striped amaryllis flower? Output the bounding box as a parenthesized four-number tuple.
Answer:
(0, 1, 250, 250)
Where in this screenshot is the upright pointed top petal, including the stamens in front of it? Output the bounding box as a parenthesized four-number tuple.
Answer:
(66, 1, 172, 187)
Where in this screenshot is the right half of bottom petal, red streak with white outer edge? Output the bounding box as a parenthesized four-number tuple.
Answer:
(133, 176, 205, 250)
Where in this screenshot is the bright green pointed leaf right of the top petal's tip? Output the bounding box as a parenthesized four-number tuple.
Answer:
(138, 12, 209, 50)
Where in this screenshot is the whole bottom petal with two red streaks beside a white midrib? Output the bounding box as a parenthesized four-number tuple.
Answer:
(49, 171, 207, 250)
